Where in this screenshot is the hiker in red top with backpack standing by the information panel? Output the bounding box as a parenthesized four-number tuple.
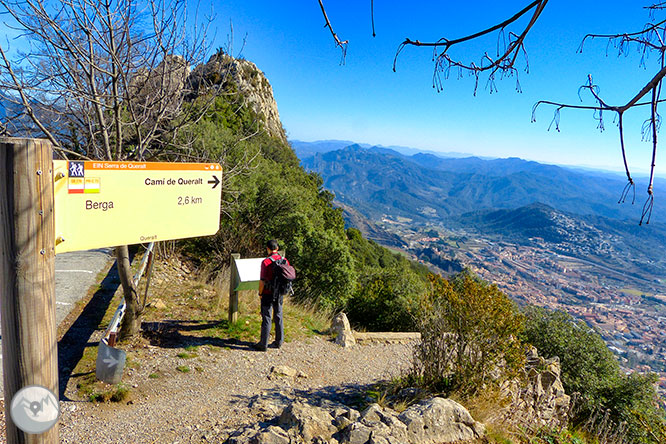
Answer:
(254, 239, 295, 351)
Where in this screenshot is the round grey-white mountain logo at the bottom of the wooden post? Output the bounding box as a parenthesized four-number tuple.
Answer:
(9, 385, 60, 434)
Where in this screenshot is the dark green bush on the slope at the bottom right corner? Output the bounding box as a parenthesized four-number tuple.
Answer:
(524, 307, 666, 444)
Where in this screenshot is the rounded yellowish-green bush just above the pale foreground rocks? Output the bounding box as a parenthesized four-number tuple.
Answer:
(411, 272, 524, 396)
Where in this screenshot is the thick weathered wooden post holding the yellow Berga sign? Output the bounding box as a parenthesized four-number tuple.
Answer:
(0, 138, 59, 444)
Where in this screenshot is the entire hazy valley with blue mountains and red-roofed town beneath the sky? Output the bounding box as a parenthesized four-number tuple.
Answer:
(296, 138, 666, 397)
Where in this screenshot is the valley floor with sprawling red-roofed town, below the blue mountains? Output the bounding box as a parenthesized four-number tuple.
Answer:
(379, 213, 666, 395)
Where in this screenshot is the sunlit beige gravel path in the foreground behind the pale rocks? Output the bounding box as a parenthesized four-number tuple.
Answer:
(60, 337, 411, 444)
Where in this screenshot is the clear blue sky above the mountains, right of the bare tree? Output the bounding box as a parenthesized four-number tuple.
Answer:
(202, 0, 666, 176)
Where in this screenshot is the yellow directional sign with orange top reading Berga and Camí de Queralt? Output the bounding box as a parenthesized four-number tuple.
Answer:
(53, 160, 222, 253)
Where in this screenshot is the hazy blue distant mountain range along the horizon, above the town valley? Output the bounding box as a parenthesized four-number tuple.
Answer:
(295, 141, 666, 224)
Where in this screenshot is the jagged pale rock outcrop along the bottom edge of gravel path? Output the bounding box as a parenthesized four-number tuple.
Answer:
(228, 398, 485, 444)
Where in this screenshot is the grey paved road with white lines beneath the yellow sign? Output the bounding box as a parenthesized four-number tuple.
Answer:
(0, 248, 113, 397)
